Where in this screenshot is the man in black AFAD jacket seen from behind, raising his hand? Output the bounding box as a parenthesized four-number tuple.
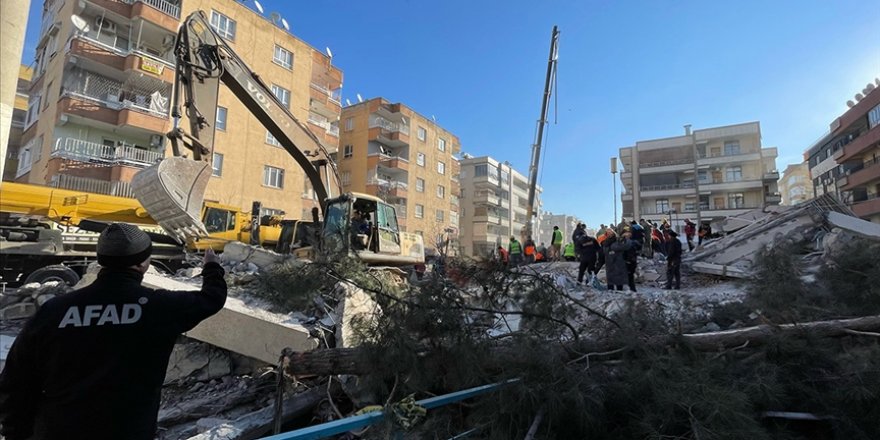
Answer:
(0, 223, 226, 440)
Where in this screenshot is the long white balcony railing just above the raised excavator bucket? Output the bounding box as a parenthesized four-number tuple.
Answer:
(51, 138, 165, 167)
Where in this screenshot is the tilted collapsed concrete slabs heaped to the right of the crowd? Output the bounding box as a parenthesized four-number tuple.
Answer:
(684, 195, 868, 278)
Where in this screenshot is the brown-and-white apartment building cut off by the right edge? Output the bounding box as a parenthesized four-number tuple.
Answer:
(804, 80, 880, 223)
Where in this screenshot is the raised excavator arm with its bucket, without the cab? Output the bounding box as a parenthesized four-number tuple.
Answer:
(132, 11, 339, 239)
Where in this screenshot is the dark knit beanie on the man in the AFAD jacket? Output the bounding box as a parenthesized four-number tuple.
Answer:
(98, 223, 153, 268)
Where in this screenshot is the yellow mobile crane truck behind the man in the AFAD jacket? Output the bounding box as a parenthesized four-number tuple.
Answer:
(0, 182, 303, 285)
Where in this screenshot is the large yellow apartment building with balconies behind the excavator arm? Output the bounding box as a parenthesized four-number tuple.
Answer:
(16, 0, 342, 218)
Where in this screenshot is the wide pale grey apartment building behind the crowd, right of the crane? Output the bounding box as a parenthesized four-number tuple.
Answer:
(620, 122, 781, 230)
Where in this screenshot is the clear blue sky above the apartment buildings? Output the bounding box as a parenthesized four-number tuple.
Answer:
(24, 0, 880, 226)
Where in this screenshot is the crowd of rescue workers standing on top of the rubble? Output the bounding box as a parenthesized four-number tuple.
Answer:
(497, 219, 712, 292)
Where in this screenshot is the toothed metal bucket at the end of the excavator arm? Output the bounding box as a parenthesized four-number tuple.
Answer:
(131, 157, 211, 241)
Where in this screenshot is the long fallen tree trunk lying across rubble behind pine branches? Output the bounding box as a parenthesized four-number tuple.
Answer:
(287, 316, 880, 376)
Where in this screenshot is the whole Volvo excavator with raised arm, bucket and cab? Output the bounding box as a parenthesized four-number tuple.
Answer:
(131, 11, 425, 266)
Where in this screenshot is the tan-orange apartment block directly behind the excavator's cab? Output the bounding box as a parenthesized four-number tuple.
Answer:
(336, 97, 461, 254)
